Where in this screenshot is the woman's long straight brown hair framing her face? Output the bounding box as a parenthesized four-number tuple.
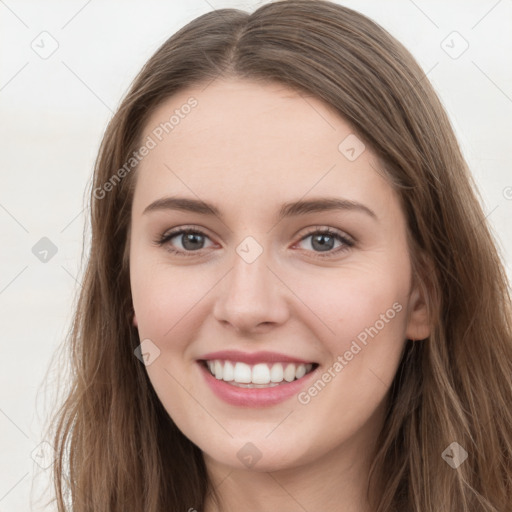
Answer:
(43, 0, 512, 512)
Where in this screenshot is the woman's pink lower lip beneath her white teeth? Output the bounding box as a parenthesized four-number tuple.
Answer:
(198, 362, 318, 407)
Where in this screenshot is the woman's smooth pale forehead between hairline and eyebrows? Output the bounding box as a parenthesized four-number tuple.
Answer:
(134, 80, 392, 219)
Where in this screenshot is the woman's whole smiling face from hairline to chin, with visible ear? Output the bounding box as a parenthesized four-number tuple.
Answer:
(130, 80, 429, 471)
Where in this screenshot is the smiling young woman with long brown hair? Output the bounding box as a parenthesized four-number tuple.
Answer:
(45, 0, 512, 512)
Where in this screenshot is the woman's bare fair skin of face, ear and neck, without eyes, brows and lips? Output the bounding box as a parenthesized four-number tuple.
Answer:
(130, 79, 429, 512)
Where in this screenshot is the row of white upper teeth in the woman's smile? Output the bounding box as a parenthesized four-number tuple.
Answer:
(206, 359, 313, 387)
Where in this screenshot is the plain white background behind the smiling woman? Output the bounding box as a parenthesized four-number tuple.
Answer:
(0, 0, 512, 512)
